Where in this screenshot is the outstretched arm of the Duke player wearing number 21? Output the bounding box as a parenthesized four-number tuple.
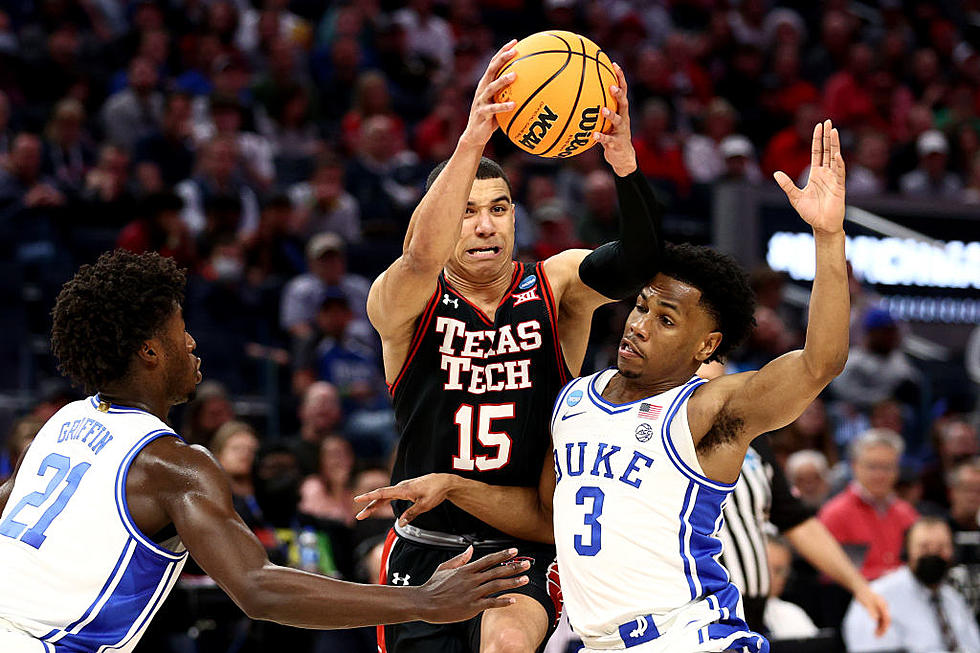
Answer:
(138, 438, 527, 628)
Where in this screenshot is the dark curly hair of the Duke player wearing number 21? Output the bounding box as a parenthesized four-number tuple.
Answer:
(51, 249, 187, 392)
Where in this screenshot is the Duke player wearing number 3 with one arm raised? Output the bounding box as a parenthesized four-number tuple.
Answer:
(360, 121, 888, 653)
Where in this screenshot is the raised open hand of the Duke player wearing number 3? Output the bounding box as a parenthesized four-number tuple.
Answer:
(773, 120, 846, 233)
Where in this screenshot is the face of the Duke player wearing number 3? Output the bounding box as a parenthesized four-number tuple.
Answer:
(617, 274, 721, 382)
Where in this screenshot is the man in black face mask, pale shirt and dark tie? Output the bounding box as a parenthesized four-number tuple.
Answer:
(842, 517, 980, 653)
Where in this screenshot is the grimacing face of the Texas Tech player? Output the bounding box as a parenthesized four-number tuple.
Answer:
(453, 177, 514, 278)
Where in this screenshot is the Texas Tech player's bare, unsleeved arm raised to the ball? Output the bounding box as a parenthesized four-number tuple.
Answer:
(367, 40, 516, 338)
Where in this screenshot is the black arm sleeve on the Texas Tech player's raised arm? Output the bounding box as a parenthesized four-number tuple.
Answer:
(578, 170, 663, 299)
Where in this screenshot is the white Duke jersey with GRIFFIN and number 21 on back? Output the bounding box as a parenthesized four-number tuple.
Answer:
(0, 396, 187, 652)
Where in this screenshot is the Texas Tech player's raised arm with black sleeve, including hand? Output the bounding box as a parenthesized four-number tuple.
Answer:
(545, 64, 663, 319)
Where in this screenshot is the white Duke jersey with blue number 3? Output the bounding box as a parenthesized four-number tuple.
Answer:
(552, 369, 761, 651)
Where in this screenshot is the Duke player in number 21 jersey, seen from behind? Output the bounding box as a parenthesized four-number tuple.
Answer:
(0, 250, 527, 653)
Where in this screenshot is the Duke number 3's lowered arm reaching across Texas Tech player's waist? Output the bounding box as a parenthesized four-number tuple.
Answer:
(354, 450, 555, 544)
